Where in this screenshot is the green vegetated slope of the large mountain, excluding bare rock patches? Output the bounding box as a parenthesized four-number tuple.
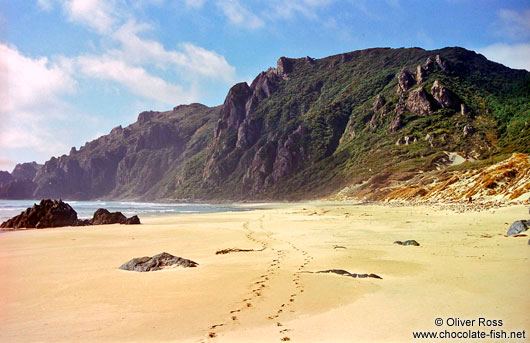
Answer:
(166, 48, 530, 199)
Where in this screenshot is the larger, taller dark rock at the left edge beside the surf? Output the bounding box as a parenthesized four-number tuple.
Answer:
(0, 199, 84, 229)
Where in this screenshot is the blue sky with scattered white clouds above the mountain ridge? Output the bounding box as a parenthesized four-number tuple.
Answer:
(0, 0, 530, 171)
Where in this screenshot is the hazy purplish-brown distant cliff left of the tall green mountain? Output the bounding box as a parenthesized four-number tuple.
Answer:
(25, 104, 219, 199)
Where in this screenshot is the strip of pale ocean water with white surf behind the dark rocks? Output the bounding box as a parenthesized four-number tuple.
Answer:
(0, 200, 250, 223)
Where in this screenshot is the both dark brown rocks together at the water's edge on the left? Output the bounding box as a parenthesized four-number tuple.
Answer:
(0, 199, 140, 229)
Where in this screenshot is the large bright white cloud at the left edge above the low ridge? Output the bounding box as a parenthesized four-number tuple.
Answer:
(0, 44, 76, 164)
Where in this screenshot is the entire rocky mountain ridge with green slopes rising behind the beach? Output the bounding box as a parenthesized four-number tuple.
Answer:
(0, 48, 530, 200)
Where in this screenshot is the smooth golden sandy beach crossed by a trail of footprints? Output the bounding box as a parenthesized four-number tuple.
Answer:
(0, 203, 530, 342)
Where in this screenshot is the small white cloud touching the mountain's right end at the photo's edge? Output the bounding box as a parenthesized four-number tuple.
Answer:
(477, 43, 530, 71)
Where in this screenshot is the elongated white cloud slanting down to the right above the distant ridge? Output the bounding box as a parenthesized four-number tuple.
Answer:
(77, 56, 196, 105)
